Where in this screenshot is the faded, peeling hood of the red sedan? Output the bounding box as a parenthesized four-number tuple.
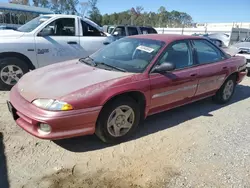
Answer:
(17, 60, 134, 102)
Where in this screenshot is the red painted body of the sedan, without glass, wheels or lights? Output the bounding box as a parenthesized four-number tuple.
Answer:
(10, 34, 246, 139)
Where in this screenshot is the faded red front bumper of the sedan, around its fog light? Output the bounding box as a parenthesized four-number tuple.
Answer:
(9, 86, 102, 140)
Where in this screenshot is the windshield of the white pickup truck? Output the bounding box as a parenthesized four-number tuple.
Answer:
(17, 16, 51, 32)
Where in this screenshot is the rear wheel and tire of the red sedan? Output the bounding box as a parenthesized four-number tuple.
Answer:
(213, 75, 236, 104)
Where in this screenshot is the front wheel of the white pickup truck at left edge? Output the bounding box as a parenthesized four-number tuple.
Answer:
(0, 57, 29, 90)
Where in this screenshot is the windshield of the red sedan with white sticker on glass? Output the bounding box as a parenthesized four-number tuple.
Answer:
(87, 38, 165, 73)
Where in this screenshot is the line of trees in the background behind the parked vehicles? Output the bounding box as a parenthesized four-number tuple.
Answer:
(10, 0, 193, 27)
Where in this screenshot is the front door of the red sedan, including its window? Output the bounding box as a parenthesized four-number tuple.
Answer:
(149, 40, 198, 112)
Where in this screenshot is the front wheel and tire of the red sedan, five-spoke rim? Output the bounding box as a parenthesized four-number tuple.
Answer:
(96, 97, 140, 144)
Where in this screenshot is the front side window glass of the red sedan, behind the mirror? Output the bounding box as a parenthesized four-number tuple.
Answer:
(158, 41, 193, 69)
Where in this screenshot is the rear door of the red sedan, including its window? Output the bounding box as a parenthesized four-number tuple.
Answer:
(192, 39, 229, 96)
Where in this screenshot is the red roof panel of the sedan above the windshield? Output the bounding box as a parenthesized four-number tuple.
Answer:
(129, 34, 204, 43)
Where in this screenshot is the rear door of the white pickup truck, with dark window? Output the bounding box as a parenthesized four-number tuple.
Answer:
(78, 20, 110, 58)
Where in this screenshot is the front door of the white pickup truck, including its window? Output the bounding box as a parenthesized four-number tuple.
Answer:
(35, 18, 81, 67)
